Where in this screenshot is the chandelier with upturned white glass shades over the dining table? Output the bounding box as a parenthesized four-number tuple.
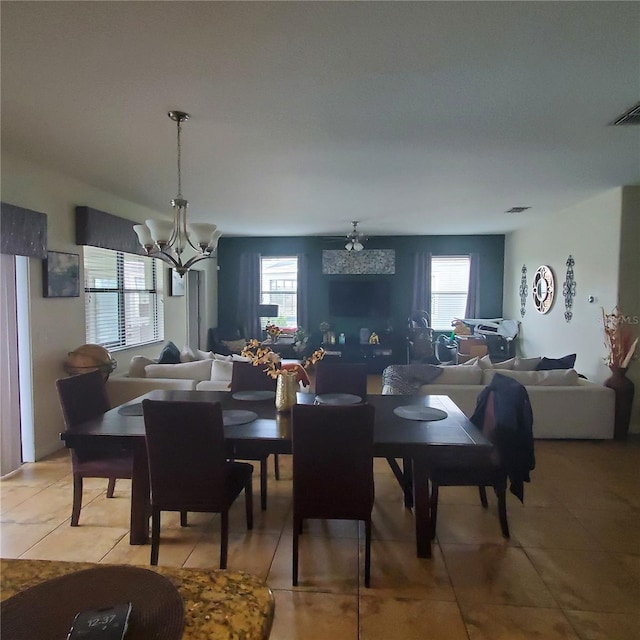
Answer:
(133, 111, 222, 276)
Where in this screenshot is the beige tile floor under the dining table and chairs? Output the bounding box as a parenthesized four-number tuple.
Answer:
(0, 430, 640, 640)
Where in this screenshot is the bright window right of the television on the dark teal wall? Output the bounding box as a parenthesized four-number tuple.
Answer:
(431, 256, 471, 331)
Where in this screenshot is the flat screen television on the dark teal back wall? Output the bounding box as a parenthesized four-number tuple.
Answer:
(329, 280, 391, 318)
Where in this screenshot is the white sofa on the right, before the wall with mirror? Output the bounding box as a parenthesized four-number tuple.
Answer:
(382, 358, 614, 440)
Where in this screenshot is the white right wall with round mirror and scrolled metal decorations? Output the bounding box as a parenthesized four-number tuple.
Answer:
(504, 187, 640, 431)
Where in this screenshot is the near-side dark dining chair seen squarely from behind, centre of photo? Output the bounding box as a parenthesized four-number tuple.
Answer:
(291, 404, 374, 587)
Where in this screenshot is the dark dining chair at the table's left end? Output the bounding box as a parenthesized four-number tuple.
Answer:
(56, 370, 133, 527)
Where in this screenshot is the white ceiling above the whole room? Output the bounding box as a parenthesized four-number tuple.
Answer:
(1, 1, 640, 236)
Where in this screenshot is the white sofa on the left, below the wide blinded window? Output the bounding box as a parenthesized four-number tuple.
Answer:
(106, 356, 238, 407)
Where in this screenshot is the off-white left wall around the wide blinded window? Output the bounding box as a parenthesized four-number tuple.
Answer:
(2, 154, 186, 460)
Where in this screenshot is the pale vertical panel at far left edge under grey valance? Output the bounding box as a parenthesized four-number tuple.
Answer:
(0, 254, 22, 476)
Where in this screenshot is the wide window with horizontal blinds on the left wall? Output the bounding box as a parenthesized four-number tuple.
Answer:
(84, 247, 164, 349)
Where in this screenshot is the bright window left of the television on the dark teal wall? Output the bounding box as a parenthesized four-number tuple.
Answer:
(260, 256, 298, 329)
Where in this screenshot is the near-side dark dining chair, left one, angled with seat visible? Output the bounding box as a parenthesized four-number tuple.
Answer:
(142, 400, 253, 569)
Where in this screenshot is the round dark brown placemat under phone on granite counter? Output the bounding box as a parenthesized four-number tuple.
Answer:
(0, 566, 184, 640)
